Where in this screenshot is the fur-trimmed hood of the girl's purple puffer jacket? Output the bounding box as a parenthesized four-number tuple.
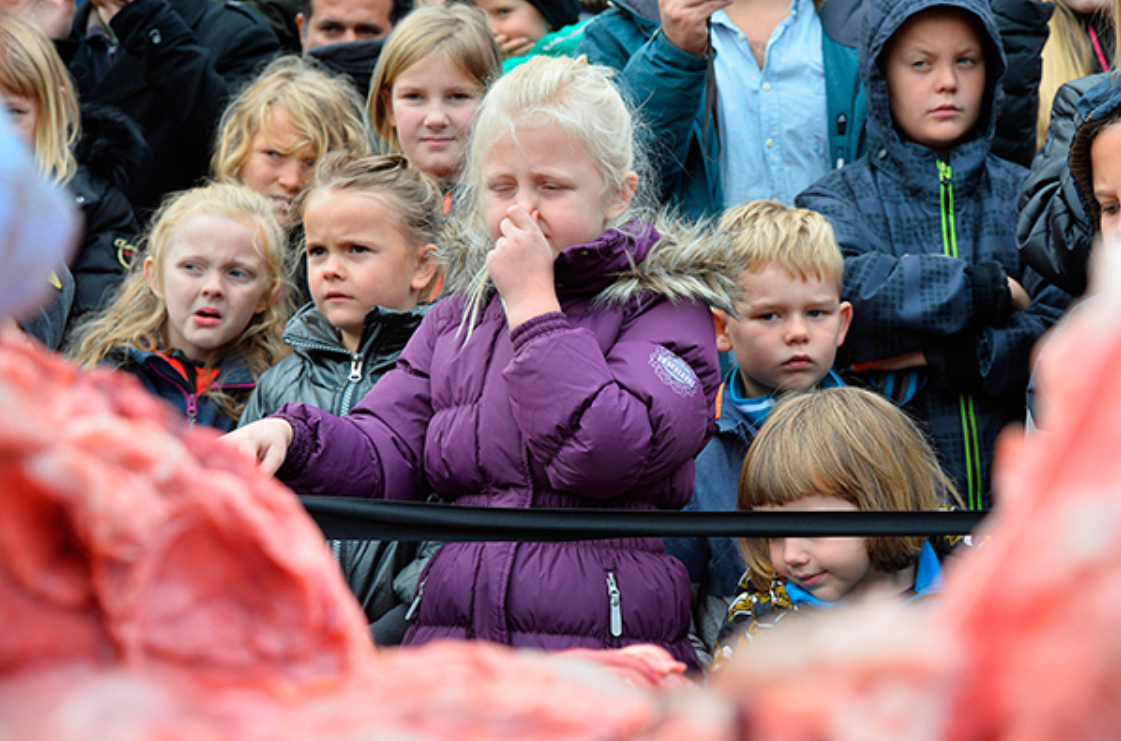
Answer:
(441, 215, 747, 315)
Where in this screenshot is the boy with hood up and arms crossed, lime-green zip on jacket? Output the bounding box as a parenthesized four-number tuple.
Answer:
(797, 0, 1068, 509)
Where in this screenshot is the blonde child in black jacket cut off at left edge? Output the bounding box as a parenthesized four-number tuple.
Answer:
(0, 16, 140, 340)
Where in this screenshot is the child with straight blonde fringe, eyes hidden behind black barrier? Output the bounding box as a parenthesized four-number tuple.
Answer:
(716, 387, 957, 665)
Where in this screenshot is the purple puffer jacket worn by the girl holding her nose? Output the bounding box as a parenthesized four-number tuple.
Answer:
(278, 222, 735, 666)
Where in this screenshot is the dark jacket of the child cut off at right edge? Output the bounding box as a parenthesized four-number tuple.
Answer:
(1016, 72, 1121, 296)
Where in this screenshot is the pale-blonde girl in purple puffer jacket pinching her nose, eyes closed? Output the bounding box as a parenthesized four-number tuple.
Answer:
(226, 57, 742, 667)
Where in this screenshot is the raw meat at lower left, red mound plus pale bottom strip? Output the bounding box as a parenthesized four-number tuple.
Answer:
(0, 341, 735, 741)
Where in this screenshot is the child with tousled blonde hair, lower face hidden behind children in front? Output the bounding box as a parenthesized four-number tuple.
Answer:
(211, 56, 371, 228)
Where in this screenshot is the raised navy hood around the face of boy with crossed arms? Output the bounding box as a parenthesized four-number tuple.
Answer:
(860, 0, 1006, 164)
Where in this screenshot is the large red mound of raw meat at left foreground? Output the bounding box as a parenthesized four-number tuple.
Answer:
(0, 331, 373, 692)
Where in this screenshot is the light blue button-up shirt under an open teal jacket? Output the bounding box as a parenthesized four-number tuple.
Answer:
(711, 0, 830, 209)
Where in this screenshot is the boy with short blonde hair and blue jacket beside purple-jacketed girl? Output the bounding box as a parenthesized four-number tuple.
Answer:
(666, 201, 852, 661)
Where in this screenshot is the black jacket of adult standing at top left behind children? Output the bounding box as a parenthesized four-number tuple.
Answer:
(58, 0, 280, 219)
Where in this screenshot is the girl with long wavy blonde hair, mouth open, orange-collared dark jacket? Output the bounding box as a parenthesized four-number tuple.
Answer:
(73, 183, 288, 429)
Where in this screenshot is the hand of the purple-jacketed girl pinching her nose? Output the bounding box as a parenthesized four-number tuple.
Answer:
(487, 205, 561, 330)
